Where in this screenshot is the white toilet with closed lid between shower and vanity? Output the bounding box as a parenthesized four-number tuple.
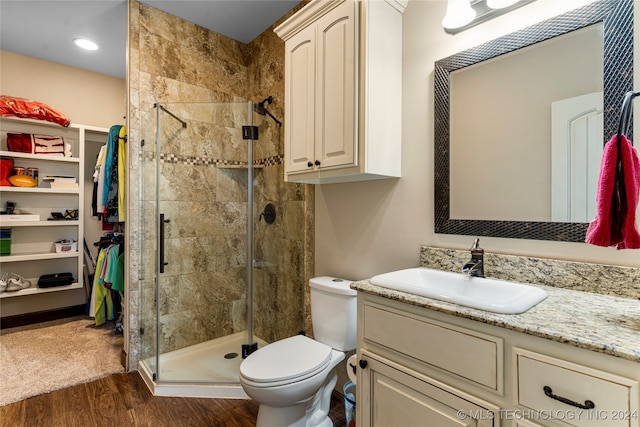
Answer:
(240, 276, 357, 427)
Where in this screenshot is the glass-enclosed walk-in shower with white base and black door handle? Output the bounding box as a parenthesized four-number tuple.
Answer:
(139, 98, 305, 397)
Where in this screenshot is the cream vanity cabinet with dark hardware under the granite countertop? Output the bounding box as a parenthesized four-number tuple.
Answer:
(356, 292, 640, 427)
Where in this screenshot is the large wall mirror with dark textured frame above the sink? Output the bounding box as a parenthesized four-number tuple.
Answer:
(434, 0, 633, 242)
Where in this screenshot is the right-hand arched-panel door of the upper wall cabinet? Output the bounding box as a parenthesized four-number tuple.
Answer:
(315, 1, 357, 168)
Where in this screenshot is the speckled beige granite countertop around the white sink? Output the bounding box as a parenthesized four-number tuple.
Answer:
(351, 280, 640, 363)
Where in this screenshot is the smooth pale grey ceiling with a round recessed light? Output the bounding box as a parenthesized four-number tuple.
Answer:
(0, 0, 300, 78)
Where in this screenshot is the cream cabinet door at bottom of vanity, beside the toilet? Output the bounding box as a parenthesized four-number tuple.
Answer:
(356, 355, 499, 427)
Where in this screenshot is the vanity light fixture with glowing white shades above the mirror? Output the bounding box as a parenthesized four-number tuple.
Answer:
(442, 0, 535, 34)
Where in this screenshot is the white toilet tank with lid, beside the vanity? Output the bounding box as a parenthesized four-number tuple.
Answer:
(309, 276, 357, 351)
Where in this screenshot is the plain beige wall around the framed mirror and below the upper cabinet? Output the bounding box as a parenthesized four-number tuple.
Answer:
(315, 0, 640, 279)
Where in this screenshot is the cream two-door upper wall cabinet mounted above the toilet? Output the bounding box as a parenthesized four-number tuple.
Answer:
(275, 0, 406, 184)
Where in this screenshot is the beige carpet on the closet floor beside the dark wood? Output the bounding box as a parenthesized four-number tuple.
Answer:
(0, 316, 124, 406)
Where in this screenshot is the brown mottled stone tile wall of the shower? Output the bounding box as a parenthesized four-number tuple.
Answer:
(127, 1, 313, 370)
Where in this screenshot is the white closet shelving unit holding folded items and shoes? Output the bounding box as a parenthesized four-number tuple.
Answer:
(0, 117, 109, 312)
